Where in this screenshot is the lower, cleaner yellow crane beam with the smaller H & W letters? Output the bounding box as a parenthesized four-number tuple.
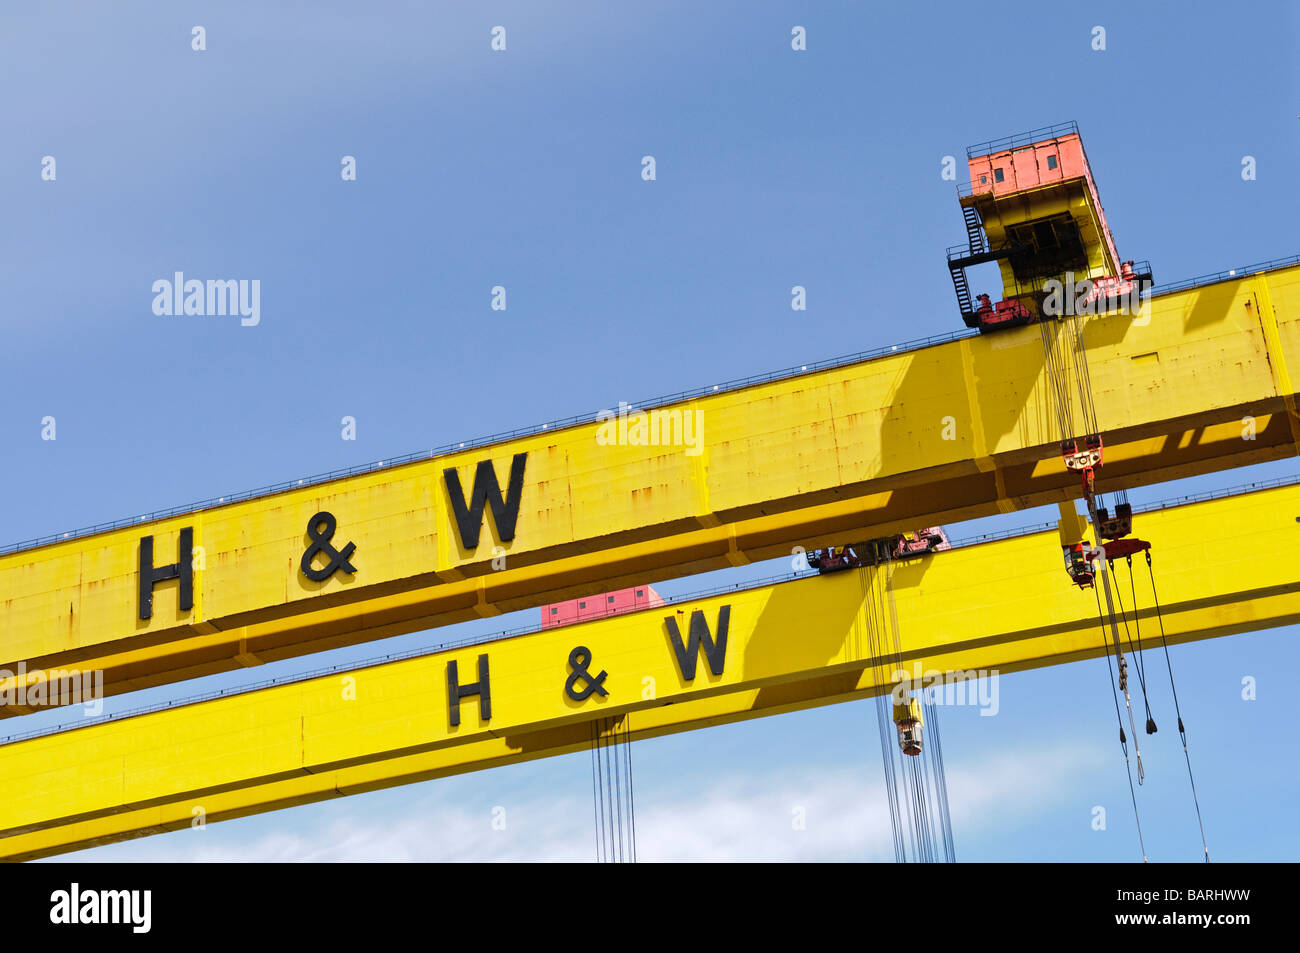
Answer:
(0, 484, 1300, 859)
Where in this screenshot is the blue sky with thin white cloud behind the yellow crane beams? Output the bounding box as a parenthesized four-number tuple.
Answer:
(0, 3, 1300, 859)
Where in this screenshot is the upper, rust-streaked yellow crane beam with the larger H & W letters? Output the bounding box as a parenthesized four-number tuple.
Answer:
(0, 267, 1300, 714)
